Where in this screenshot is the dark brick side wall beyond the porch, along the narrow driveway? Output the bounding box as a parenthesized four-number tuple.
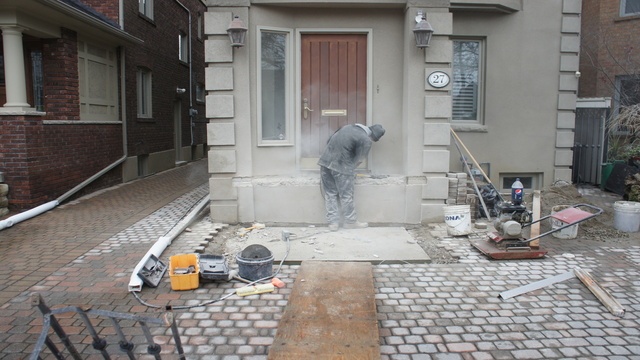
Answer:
(124, 0, 206, 156)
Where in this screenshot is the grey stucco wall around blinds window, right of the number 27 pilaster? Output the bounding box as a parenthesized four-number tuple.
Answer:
(451, 0, 579, 187)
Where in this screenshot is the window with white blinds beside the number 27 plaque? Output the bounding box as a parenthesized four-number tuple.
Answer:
(452, 40, 482, 122)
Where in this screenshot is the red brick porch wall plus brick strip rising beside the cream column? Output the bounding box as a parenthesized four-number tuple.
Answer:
(0, 29, 123, 212)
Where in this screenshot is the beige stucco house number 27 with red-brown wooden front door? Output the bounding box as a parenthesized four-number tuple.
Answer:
(204, 0, 582, 224)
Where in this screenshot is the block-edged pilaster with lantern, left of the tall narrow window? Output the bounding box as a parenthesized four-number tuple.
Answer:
(204, 0, 252, 223)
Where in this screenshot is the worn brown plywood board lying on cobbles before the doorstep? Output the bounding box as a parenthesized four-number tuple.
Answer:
(268, 261, 380, 360)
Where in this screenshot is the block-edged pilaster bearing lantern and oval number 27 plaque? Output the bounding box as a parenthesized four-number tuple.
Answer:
(405, 1, 453, 223)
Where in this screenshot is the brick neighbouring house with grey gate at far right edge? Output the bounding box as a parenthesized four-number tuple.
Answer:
(573, 0, 640, 186)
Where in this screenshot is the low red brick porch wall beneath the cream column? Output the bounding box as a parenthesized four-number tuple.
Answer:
(0, 116, 122, 212)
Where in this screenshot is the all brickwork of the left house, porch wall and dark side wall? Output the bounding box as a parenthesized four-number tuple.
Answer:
(0, 0, 206, 212)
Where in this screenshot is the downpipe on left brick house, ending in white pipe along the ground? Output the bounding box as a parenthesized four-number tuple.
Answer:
(0, 47, 128, 231)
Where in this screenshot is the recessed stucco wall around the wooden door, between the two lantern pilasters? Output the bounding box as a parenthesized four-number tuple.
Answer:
(245, 6, 404, 176)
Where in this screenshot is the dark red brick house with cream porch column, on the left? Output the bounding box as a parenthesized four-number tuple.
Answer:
(0, 0, 206, 212)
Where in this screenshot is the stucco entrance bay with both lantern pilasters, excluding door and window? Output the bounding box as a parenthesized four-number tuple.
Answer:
(205, 1, 451, 223)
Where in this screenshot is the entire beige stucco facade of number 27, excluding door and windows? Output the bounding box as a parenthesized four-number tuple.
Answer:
(205, 0, 580, 223)
